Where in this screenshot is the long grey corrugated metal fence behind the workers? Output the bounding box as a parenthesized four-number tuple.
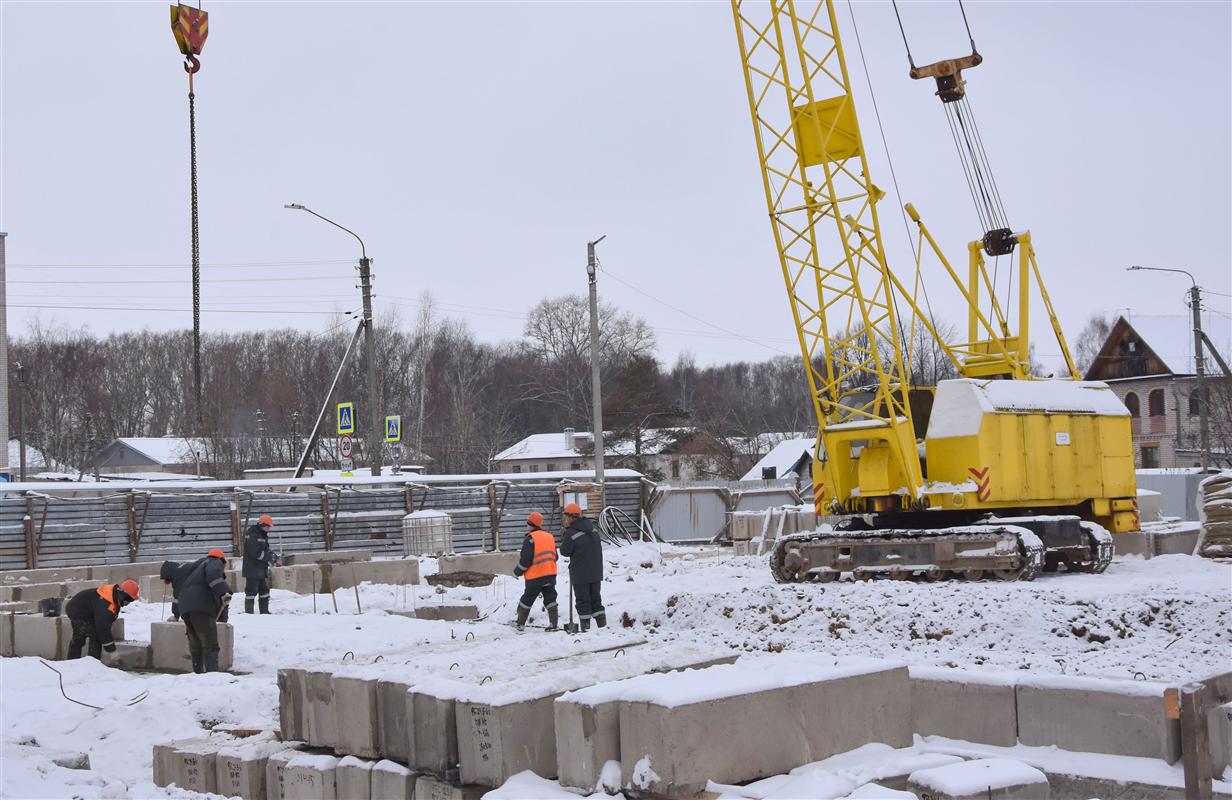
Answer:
(0, 480, 643, 569)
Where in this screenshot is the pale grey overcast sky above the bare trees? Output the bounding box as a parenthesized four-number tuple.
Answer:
(0, 0, 1232, 365)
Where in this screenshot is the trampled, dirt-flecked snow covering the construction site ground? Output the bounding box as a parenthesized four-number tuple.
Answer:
(0, 545, 1232, 798)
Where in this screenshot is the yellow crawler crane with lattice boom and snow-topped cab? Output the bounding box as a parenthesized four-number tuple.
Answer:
(732, 0, 1138, 582)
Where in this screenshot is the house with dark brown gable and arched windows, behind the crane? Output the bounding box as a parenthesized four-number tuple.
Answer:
(1083, 312, 1232, 470)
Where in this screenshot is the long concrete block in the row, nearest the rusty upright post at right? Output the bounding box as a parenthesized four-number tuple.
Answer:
(1016, 676, 1180, 764)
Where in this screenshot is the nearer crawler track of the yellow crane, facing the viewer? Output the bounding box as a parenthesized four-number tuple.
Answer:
(770, 524, 1044, 583)
